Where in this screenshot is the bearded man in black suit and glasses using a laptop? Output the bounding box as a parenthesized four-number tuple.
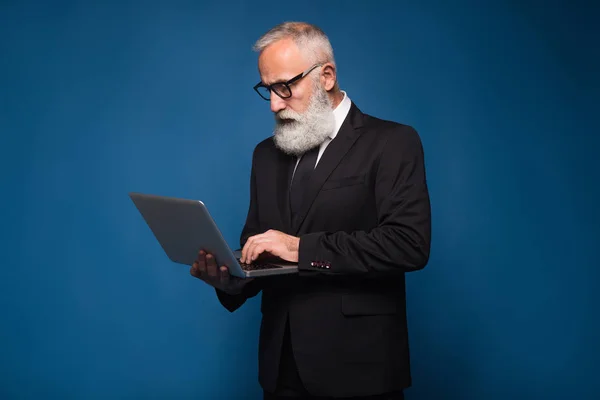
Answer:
(191, 23, 431, 399)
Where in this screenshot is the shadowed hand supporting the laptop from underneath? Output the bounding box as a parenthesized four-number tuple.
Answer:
(190, 250, 253, 294)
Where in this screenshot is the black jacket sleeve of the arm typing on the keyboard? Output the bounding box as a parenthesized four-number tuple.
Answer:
(299, 125, 431, 277)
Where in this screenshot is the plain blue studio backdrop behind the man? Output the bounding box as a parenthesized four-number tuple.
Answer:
(0, 0, 600, 400)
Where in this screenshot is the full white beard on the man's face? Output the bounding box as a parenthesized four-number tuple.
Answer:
(274, 84, 335, 156)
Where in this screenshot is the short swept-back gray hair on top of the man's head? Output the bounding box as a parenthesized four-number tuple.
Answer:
(254, 22, 335, 66)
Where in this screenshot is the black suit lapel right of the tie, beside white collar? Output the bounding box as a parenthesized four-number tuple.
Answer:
(288, 103, 362, 234)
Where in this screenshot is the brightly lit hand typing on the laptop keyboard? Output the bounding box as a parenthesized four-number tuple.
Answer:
(240, 229, 300, 264)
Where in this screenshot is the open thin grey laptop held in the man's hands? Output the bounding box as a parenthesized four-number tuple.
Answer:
(129, 193, 298, 278)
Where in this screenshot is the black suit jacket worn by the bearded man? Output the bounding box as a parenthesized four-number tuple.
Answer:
(217, 104, 431, 396)
